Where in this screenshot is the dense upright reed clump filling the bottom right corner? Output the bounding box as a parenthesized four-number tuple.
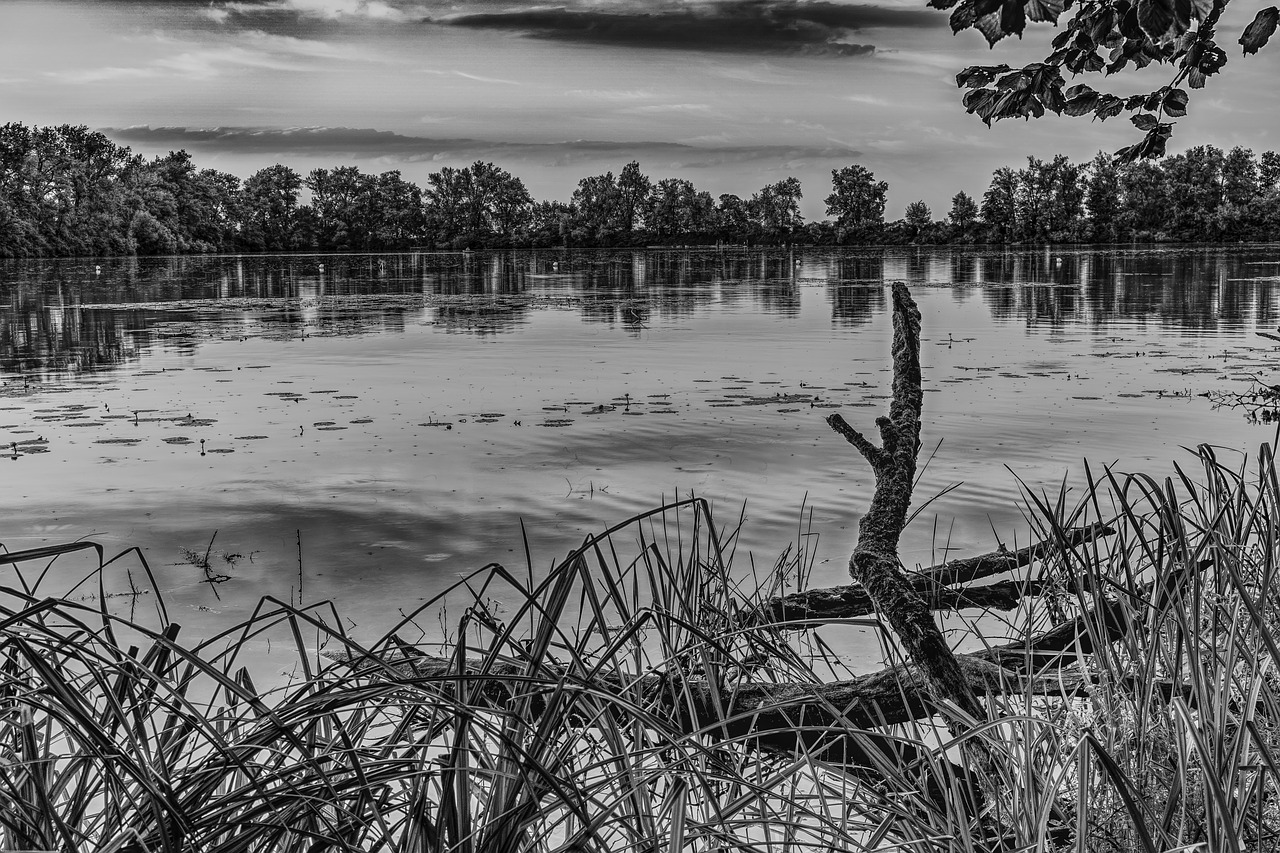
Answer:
(1013, 446, 1280, 850)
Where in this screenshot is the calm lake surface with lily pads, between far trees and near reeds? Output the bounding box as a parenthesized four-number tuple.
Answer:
(0, 247, 1280, 655)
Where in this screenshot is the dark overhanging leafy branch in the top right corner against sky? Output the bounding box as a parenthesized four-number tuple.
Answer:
(928, 0, 1280, 157)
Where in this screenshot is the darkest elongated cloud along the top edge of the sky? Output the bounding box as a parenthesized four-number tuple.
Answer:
(436, 0, 946, 56)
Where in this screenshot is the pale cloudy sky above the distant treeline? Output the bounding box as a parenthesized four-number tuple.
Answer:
(0, 0, 1280, 218)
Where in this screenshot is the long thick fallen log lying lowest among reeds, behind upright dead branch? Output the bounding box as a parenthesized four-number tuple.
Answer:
(326, 545, 1210, 732)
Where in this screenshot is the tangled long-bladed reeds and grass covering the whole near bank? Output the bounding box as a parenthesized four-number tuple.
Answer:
(0, 446, 1280, 853)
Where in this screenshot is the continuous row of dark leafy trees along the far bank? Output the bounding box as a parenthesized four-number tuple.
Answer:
(0, 123, 1280, 257)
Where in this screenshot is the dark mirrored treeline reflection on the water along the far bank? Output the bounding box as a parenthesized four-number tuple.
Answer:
(0, 247, 1280, 373)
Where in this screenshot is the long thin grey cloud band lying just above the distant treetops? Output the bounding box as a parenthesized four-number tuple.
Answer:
(101, 127, 859, 168)
